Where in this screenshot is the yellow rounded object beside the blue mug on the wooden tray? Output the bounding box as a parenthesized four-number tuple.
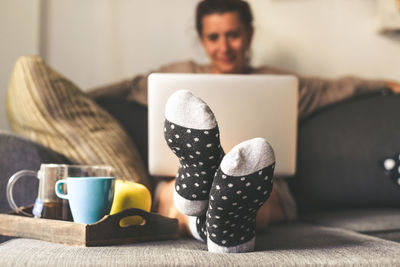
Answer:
(110, 180, 151, 227)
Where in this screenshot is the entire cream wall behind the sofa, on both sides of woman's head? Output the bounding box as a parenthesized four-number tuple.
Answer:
(0, 0, 400, 128)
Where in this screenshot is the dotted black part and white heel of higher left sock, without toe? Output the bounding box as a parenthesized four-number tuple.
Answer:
(165, 120, 223, 216)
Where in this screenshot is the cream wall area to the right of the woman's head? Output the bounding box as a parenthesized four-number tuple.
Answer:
(250, 0, 400, 80)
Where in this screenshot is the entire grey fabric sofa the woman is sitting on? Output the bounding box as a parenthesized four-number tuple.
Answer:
(0, 86, 400, 266)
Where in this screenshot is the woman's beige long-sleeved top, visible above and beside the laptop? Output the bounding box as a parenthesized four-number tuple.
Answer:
(88, 61, 387, 120)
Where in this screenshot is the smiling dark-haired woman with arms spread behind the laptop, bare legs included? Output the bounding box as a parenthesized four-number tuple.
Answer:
(91, 0, 400, 253)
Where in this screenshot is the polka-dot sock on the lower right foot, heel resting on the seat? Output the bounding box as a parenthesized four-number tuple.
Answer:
(206, 138, 275, 253)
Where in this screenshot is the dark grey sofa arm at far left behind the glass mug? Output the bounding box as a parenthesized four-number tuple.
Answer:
(0, 132, 72, 242)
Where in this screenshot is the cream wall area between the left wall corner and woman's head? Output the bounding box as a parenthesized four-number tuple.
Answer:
(42, 0, 203, 89)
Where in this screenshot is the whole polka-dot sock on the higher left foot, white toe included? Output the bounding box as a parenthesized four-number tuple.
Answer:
(164, 90, 224, 216)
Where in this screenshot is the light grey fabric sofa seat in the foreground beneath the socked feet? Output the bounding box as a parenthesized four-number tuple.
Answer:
(0, 223, 400, 266)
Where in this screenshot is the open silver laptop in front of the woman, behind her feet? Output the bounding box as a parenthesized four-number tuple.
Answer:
(148, 73, 298, 177)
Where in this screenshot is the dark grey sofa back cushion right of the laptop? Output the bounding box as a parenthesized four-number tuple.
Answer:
(289, 95, 400, 214)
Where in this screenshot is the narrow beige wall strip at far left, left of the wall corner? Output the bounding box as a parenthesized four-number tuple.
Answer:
(0, 0, 40, 130)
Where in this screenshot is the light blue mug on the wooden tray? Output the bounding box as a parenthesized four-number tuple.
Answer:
(55, 177, 115, 224)
